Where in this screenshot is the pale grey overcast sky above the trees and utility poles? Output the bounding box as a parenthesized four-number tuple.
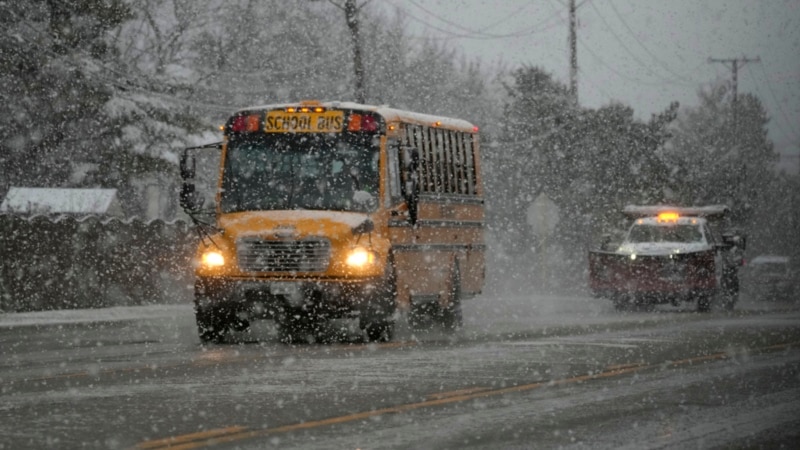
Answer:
(378, 0, 800, 172)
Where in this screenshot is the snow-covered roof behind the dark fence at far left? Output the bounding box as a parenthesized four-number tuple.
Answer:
(0, 187, 117, 214)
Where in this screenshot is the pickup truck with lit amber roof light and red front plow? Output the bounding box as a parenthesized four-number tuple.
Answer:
(589, 205, 744, 312)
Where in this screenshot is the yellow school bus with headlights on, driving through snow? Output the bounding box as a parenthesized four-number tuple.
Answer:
(181, 101, 485, 342)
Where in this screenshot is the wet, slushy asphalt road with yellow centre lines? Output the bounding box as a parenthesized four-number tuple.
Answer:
(0, 296, 800, 449)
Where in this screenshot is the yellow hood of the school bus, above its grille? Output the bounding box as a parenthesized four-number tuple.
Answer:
(218, 210, 369, 240)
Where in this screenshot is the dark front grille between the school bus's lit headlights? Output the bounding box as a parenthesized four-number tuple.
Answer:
(236, 238, 331, 272)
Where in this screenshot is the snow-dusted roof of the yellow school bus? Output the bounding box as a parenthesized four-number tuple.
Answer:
(237, 101, 477, 132)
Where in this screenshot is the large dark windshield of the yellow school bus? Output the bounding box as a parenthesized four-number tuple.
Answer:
(220, 133, 380, 213)
